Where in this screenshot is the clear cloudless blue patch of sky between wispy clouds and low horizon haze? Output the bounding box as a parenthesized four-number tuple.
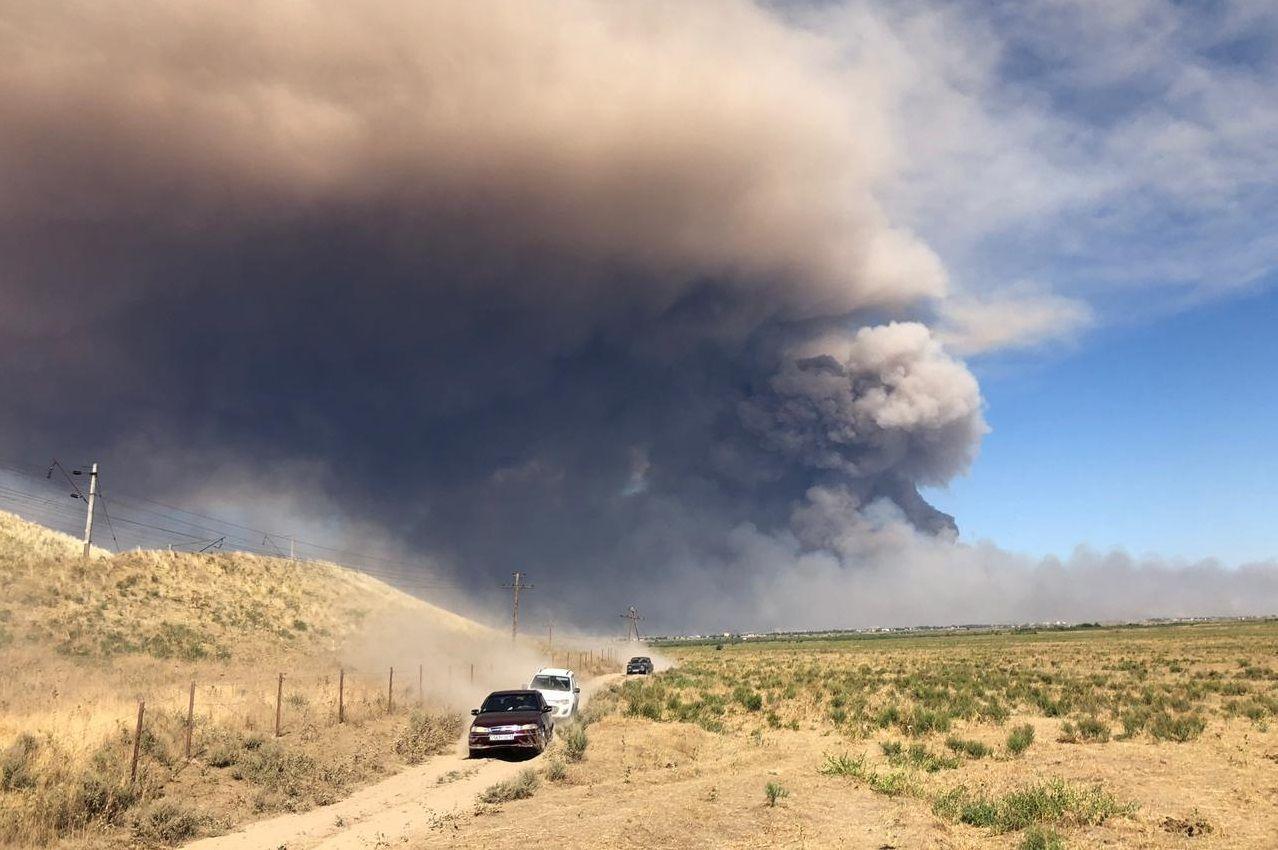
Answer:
(929, 278, 1278, 564)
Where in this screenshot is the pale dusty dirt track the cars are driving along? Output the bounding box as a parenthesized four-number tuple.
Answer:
(187, 674, 621, 850)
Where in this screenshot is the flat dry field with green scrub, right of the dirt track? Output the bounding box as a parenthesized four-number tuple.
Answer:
(412, 622, 1278, 850)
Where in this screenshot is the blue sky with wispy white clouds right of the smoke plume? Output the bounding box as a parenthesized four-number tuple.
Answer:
(854, 0, 1278, 564)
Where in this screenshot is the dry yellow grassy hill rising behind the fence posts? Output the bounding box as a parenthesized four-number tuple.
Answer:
(0, 511, 487, 661)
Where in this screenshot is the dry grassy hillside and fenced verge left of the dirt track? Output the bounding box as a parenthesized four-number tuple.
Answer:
(0, 513, 613, 847)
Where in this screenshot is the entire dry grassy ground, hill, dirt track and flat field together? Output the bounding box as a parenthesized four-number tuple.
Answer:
(9, 503, 1278, 850)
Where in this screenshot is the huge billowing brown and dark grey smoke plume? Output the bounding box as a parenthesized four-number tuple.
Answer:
(0, 0, 1272, 628)
